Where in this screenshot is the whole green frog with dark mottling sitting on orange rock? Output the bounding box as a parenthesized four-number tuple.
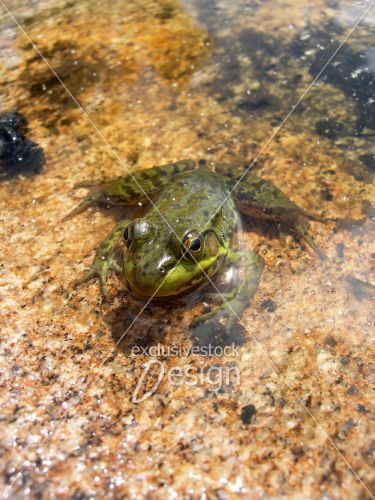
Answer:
(69, 160, 322, 323)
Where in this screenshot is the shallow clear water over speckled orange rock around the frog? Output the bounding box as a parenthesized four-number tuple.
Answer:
(0, 0, 375, 499)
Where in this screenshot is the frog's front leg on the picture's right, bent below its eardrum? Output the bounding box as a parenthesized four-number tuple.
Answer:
(192, 250, 264, 327)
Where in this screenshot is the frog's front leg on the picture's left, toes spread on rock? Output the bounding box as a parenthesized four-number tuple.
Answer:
(73, 219, 130, 297)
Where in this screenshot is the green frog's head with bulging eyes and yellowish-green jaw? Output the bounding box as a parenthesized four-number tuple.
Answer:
(123, 218, 226, 297)
